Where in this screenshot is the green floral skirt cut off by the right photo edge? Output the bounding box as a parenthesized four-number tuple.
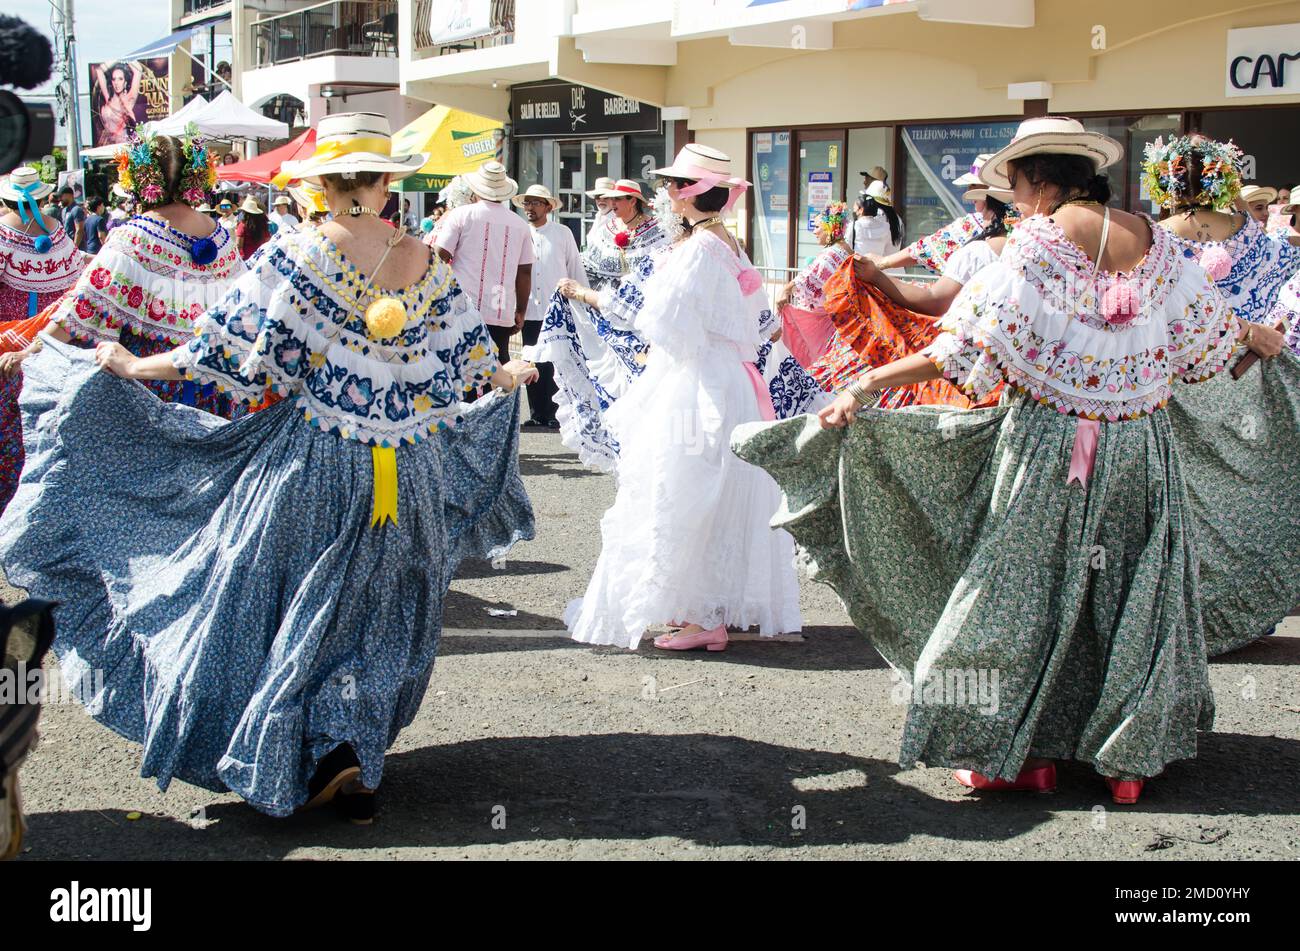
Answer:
(1169, 352, 1300, 657)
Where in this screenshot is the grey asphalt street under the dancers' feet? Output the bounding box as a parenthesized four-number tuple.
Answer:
(5, 433, 1300, 861)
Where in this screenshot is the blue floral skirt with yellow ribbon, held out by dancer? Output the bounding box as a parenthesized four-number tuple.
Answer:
(0, 343, 533, 816)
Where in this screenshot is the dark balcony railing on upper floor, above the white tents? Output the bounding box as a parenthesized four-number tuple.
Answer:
(252, 0, 398, 68)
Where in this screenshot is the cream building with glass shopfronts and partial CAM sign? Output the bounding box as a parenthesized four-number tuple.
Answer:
(402, 0, 1300, 270)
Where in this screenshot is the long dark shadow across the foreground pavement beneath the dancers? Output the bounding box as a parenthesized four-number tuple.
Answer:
(17, 733, 1300, 860)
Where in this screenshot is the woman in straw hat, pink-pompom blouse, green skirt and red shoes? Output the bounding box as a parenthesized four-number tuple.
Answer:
(733, 117, 1290, 803)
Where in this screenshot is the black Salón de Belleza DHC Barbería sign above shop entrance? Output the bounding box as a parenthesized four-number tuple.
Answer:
(510, 82, 660, 139)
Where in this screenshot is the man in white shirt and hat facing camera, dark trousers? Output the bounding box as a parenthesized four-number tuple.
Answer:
(514, 184, 586, 429)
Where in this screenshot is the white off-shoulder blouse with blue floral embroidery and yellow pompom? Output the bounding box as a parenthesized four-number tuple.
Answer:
(176, 230, 497, 447)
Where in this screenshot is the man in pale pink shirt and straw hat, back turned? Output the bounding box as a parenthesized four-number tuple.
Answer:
(434, 162, 533, 364)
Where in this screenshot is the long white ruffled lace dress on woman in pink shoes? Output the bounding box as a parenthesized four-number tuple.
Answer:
(564, 233, 802, 648)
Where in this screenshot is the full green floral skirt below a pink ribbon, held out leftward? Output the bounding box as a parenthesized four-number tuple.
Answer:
(732, 396, 1214, 780)
